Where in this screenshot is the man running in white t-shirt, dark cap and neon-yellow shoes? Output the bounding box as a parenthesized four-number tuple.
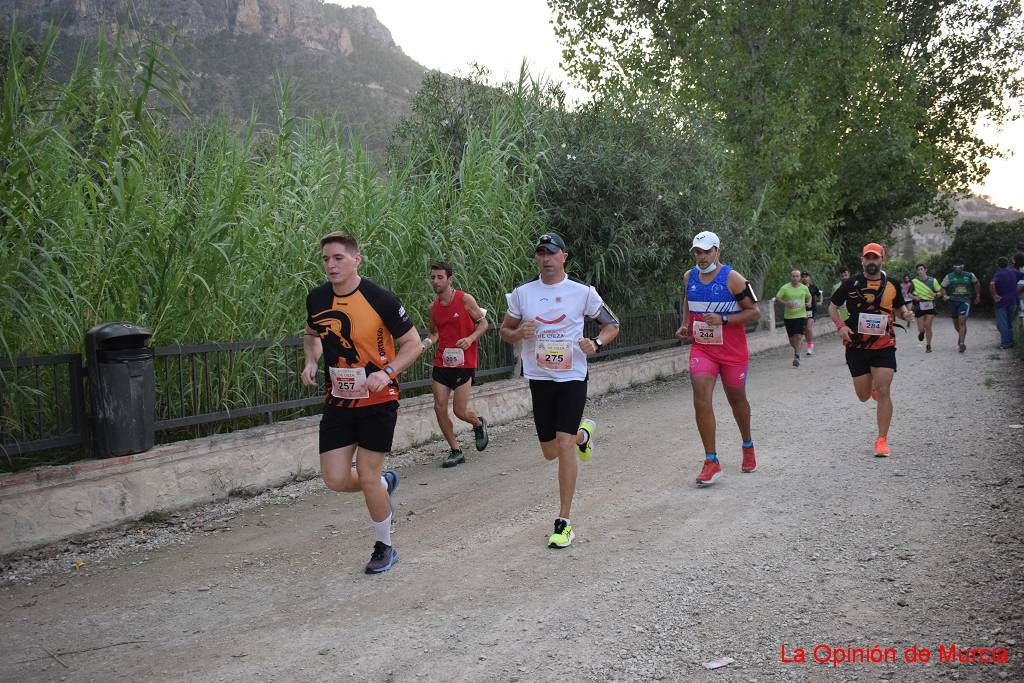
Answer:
(499, 232, 618, 548)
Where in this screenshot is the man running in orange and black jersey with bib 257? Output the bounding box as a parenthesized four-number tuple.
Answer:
(301, 232, 423, 573)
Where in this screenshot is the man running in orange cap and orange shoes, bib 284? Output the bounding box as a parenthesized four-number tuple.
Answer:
(828, 242, 913, 458)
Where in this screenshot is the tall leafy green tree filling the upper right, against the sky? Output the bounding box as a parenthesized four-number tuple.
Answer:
(550, 0, 1024, 276)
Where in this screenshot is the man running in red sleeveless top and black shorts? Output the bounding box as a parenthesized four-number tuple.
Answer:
(423, 261, 489, 467)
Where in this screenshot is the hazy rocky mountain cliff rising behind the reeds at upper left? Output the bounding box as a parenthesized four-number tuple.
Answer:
(0, 0, 426, 148)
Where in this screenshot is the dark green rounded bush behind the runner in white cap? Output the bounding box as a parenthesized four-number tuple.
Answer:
(538, 100, 733, 306)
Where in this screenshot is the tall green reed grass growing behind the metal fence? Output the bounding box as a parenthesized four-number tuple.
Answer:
(0, 32, 540, 355)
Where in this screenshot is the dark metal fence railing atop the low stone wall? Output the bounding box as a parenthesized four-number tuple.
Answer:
(0, 311, 678, 469)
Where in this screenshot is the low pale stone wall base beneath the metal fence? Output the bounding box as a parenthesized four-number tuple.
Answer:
(0, 321, 835, 554)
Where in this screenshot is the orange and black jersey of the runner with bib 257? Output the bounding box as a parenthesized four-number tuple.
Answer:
(306, 278, 413, 408)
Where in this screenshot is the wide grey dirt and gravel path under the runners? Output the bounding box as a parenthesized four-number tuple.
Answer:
(0, 319, 1024, 681)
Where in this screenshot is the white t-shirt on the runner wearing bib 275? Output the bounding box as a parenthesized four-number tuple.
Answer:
(509, 276, 604, 382)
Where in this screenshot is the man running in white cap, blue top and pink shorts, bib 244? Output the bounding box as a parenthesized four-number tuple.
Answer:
(676, 231, 761, 486)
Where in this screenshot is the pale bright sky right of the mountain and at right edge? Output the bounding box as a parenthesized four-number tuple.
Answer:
(346, 0, 1024, 209)
